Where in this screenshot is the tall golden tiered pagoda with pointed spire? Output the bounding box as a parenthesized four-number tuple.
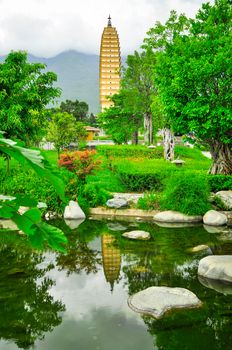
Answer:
(99, 16, 121, 111)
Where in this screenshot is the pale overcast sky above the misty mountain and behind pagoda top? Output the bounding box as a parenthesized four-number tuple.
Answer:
(0, 0, 213, 57)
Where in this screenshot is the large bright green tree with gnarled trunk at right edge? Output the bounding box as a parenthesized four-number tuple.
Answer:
(146, 0, 232, 174)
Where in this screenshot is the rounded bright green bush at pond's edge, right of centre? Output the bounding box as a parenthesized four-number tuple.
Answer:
(160, 171, 210, 215)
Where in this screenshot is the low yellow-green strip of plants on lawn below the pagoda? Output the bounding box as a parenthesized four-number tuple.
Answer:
(97, 145, 163, 159)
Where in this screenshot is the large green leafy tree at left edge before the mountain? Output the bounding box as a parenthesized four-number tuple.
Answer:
(0, 51, 60, 145)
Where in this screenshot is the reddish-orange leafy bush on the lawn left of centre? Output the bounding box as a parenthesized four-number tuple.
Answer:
(58, 150, 101, 180)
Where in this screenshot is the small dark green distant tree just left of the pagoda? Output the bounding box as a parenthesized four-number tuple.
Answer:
(60, 100, 89, 122)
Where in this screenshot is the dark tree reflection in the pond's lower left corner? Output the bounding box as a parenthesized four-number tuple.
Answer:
(0, 233, 65, 349)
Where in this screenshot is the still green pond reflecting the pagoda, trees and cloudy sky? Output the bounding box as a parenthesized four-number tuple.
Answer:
(0, 220, 232, 350)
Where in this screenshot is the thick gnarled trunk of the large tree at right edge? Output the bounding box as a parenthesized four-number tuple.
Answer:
(209, 141, 232, 175)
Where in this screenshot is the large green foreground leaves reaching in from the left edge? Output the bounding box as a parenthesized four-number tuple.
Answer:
(0, 134, 67, 250)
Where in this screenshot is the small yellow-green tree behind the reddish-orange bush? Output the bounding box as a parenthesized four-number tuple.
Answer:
(46, 112, 87, 154)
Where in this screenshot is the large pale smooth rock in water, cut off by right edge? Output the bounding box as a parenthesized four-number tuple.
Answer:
(198, 255, 232, 283)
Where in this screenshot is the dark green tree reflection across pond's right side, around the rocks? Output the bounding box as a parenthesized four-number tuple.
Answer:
(120, 223, 232, 350)
